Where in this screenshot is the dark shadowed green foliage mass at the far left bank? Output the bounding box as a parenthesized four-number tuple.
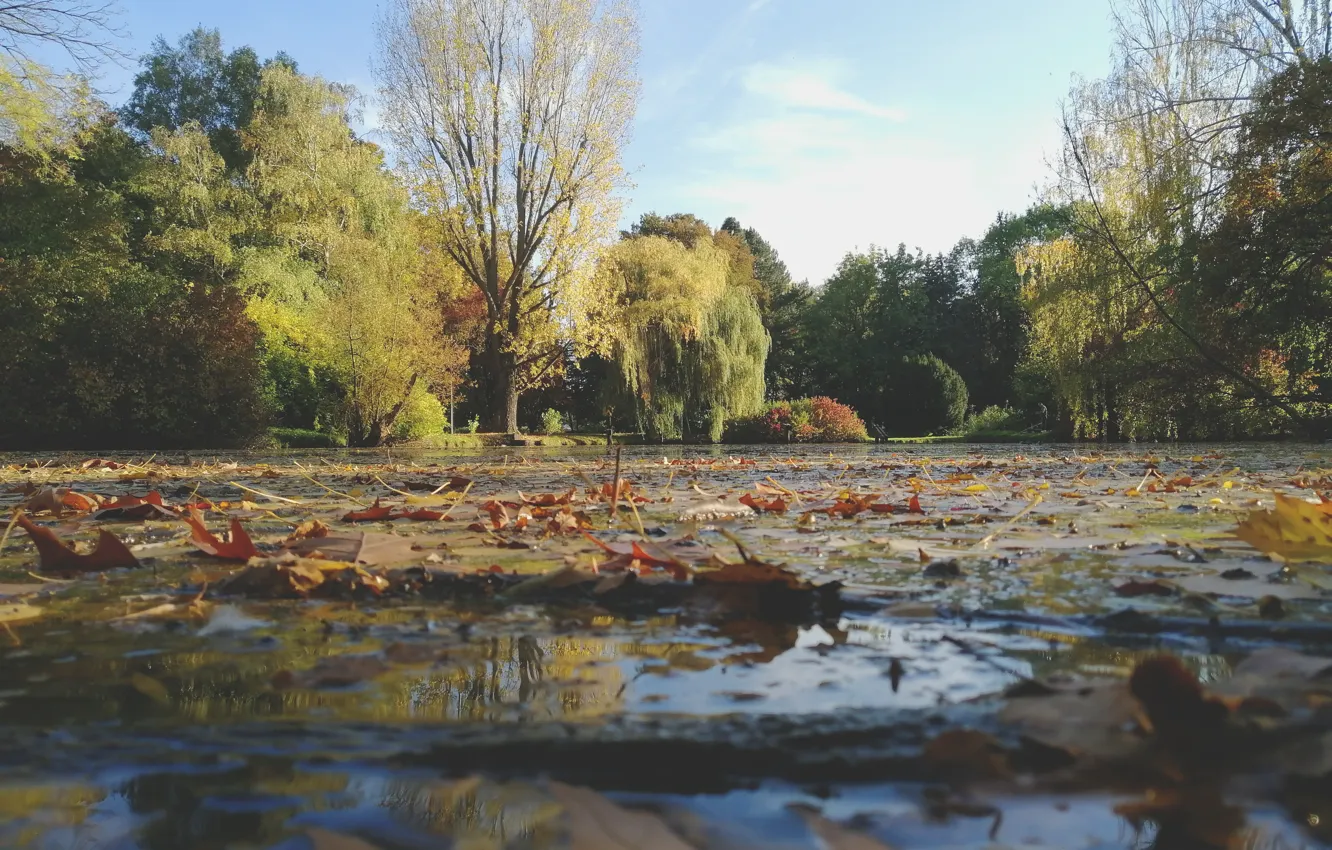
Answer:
(0, 121, 266, 448)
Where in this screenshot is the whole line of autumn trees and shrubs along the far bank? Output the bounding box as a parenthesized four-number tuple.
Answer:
(0, 0, 1332, 448)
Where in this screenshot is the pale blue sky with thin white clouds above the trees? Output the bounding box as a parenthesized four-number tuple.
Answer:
(70, 0, 1111, 282)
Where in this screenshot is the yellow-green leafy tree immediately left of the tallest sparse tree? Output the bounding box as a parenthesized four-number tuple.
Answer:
(240, 64, 462, 445)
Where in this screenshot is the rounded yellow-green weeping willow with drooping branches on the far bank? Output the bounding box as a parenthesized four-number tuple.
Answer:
(602, 236, 770, 441)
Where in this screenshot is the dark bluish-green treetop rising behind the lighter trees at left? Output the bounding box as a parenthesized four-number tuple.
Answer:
(120, 27, 296, 172)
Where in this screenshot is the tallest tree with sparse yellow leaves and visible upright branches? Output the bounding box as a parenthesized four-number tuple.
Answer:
(378, 0, 638, 432)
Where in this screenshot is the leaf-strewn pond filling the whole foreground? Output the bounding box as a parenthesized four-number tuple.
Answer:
(0, 444, 1332, 850)
